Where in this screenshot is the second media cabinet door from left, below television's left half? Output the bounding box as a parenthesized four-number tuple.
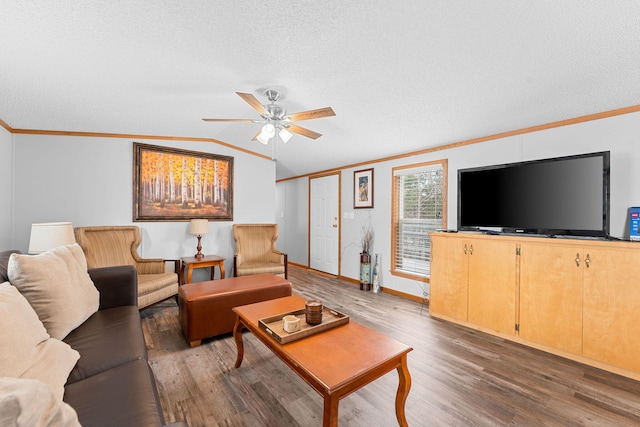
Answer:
(469, 239, 517, 334)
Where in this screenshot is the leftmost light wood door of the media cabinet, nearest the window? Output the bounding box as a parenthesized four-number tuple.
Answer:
(429, 235, 469, 321)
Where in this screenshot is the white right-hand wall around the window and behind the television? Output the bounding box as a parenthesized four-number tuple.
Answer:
(278, 108, 640, 296)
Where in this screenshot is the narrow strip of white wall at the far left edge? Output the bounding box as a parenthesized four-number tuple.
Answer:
(0, 126, 13, 247)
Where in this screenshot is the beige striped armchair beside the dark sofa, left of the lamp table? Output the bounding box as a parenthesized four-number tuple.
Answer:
(74, 225, 180, 309)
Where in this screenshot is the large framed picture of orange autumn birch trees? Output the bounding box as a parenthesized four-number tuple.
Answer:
(133, 142, 233, 221)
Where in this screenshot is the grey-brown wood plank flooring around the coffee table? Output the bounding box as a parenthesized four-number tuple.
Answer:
(141, 266, 640, 427)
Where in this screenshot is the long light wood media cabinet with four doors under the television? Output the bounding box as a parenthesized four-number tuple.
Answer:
(429, 232, 640, 380)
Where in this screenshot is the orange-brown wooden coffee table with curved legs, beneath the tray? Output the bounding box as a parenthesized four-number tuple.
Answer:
(233, 296, 413, 427)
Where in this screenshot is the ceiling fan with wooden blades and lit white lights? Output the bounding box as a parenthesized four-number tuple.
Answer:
(202, 89, 336, 145)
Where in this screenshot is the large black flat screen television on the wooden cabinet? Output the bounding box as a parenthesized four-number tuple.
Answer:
(458, 151, 610, 237)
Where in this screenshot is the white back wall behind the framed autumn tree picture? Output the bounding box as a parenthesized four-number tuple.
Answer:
(11, 135, 276, 276)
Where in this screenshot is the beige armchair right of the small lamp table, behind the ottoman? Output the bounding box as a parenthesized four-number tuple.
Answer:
(233, 224, 288, 279)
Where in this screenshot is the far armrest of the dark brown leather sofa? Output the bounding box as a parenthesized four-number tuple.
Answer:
(89, 265, 138, 310)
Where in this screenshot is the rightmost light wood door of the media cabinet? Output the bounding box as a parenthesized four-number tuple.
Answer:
(583, 248, 640, 372)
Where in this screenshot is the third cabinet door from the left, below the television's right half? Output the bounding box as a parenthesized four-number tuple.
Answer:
(519, 243, 584, 354)
